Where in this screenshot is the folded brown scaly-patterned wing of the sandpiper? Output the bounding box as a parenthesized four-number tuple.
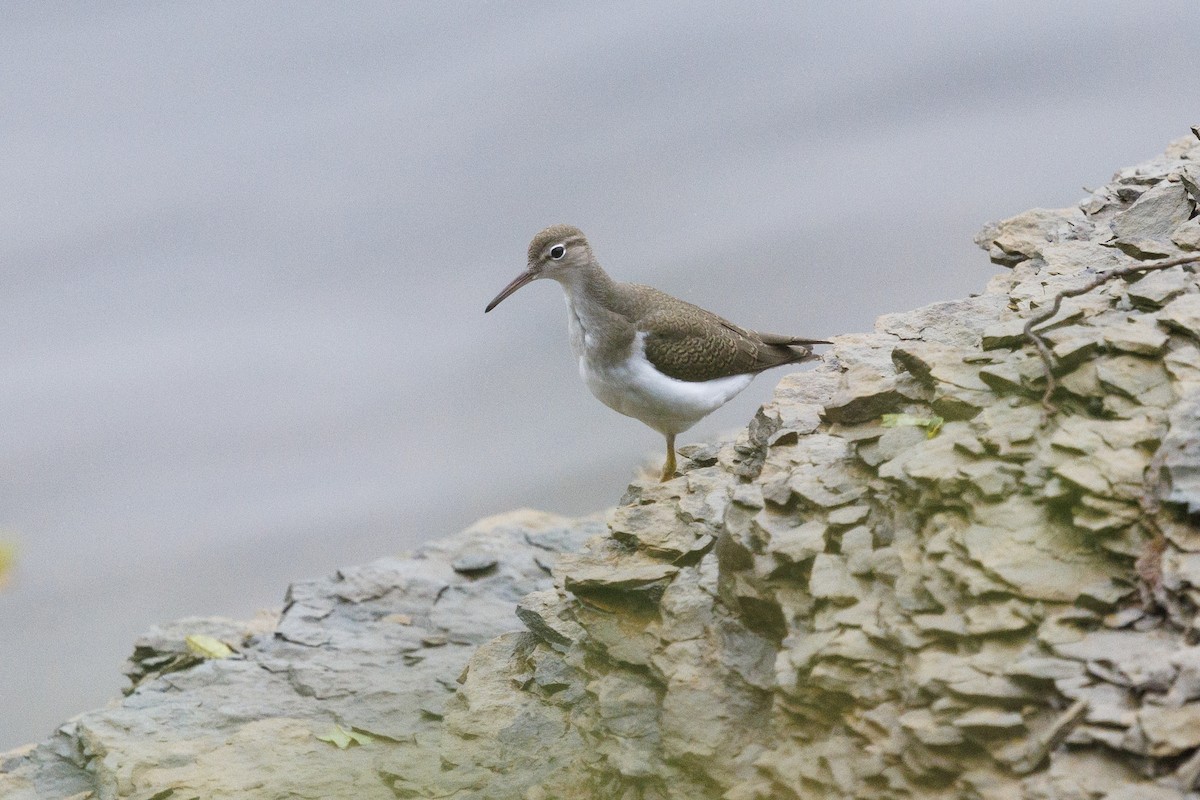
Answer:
(637, 290, 812, 381)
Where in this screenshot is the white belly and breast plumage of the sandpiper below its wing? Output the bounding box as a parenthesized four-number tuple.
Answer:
(580, 333, 754, 434)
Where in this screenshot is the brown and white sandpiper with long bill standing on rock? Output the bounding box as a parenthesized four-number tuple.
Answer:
(484, 224, 829, 481)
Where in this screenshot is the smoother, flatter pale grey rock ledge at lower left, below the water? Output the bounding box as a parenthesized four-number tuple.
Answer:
(0, 511, 605, 800)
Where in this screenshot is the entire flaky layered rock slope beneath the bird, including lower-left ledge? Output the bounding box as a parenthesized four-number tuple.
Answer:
(7, 138, 1200, 800)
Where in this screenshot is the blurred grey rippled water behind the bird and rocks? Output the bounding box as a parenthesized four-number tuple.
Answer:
(0, 0, 1200, 750)
